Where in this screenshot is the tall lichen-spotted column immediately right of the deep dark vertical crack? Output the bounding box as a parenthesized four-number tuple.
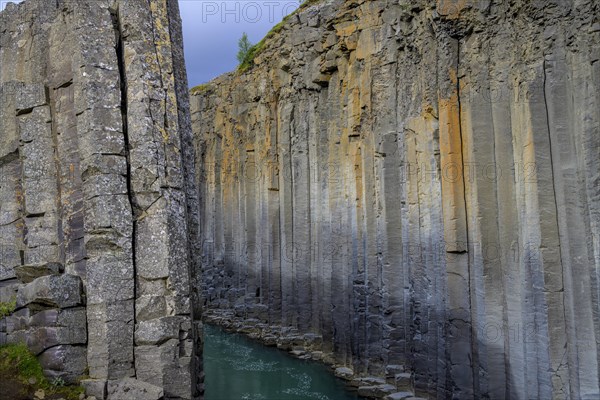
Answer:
(116, 0, 201, 398)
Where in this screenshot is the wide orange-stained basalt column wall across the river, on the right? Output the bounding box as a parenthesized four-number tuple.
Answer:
(192, 0, 600, 399)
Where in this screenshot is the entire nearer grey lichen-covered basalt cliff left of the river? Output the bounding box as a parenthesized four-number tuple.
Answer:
(0, 0, 201, 399)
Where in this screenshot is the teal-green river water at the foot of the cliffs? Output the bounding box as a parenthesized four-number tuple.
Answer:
(204, 325, 361, 400)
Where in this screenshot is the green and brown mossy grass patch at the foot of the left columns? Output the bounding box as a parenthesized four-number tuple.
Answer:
(0, 344, 84, 400)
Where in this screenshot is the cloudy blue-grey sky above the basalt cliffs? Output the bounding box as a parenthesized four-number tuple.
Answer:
(0, 0, 300, 87)
